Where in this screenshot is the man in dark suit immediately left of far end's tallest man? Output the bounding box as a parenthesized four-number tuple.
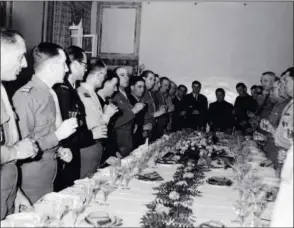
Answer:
(172, 85, 188, 131)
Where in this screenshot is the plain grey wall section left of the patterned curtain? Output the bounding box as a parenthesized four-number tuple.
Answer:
(12, 1, 44, 49)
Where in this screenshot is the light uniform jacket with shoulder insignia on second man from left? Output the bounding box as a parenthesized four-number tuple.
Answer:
(13, 76, 59, 152)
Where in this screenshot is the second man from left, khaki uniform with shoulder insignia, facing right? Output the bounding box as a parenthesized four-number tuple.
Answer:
(13, 43, 78, 204)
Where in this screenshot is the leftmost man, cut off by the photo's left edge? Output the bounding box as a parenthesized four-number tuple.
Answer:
(0, 28, 38, 220)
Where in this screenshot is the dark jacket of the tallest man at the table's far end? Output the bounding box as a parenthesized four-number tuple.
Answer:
(183, 93, 208, 130)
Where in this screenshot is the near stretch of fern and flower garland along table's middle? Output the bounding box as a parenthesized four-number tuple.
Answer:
(141, 162, 204, 228)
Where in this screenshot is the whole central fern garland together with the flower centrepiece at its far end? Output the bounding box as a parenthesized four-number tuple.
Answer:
(141, 130, 237, 228)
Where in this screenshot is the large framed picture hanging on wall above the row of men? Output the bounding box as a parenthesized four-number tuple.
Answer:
(97, 2, 141, 59)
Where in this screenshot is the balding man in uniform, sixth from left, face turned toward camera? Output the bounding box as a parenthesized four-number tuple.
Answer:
(112, 67, 145, 157)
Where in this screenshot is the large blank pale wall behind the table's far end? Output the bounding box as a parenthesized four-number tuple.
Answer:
(140, 2, 293, 101)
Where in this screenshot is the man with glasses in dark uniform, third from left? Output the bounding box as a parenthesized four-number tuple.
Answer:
(53, 46, 107, 191)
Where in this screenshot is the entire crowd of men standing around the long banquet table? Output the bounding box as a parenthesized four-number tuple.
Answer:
(1, 28, 294, 223)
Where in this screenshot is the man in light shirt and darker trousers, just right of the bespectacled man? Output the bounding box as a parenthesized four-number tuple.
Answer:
(78, 61, 117, 178)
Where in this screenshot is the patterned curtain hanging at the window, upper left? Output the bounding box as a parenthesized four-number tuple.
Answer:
(52, 1, 92, 48)
